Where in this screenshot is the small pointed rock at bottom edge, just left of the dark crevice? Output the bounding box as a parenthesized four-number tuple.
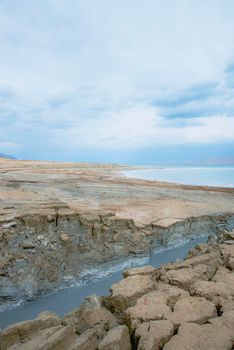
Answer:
(98, 326, 132, 350)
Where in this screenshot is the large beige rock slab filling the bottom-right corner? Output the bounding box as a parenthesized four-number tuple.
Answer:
(163, 312, 234, 350)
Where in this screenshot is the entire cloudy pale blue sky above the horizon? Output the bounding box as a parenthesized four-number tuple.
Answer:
(0, 0, 234, 164)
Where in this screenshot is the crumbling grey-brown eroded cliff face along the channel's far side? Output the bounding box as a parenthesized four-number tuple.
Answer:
(0, 209, 234, 304)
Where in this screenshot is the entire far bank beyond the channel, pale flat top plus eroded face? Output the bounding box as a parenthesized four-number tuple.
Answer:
(0, 159, 234, 349)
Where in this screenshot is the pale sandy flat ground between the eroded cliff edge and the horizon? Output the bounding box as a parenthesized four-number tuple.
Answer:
(0, 159, 234, 227)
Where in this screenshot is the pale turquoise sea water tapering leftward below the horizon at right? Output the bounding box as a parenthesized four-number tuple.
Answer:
(124, 166, 234, 188)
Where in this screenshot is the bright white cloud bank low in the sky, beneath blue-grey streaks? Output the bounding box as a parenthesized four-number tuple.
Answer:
(50, 106, 234, 150)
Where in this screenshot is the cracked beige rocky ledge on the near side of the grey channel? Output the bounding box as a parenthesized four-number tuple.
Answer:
(0, 231, 234, 350)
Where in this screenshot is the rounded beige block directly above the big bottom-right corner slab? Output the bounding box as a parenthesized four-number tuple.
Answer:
(167, 297, 217, 326)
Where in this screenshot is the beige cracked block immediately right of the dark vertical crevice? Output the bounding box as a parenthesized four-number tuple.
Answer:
(125, 292, 172, 332)
